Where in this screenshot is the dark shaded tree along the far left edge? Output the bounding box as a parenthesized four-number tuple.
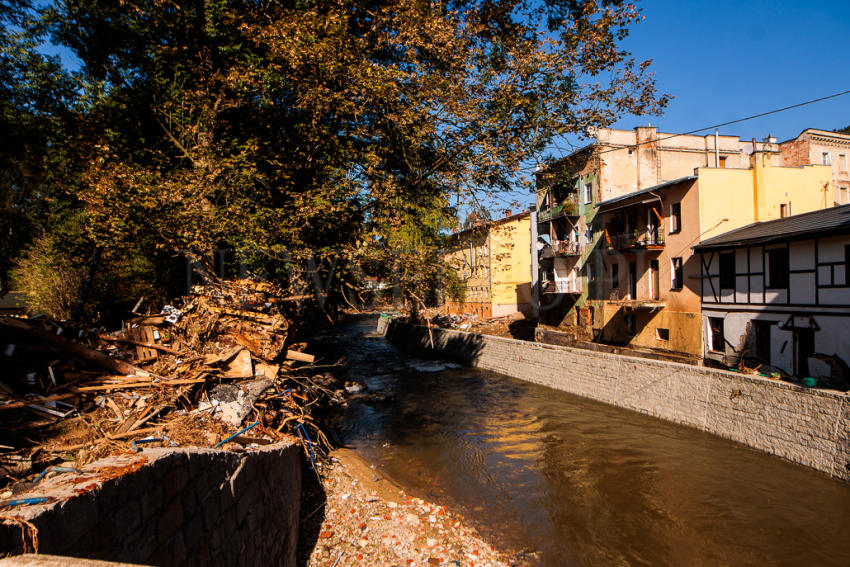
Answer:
(0, 0, 74, 295)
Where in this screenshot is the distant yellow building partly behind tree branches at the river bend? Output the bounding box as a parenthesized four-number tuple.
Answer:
(444, 212, 531, 319)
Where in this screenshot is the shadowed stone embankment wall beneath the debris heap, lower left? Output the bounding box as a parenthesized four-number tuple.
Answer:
(0, 444, 301, 566)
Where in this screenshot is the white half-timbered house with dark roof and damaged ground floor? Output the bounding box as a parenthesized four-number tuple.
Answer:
(694, 206, 850, 384)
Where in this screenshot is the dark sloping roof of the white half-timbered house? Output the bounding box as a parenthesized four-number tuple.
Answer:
(694, 205, 850, 252)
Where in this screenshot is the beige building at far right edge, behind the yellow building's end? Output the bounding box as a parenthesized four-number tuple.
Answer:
(779, 128, 850, 205)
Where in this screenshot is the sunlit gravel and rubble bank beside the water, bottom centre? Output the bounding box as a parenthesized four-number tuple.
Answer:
(299, 449, 526, 567)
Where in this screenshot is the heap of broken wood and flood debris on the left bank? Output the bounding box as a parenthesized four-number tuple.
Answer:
(0, 280, 335, 496)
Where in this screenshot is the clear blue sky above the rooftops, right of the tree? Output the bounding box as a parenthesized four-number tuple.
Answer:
(615, 0, 850, 140)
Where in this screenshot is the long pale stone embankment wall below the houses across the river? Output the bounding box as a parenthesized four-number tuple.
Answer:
(378, 317, 850, 481)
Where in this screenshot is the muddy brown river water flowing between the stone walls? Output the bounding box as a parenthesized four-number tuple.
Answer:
(327, 318, 850, 566)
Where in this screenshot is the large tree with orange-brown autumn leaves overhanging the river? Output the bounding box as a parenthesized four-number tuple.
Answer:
(38, 0, 667, 302)
